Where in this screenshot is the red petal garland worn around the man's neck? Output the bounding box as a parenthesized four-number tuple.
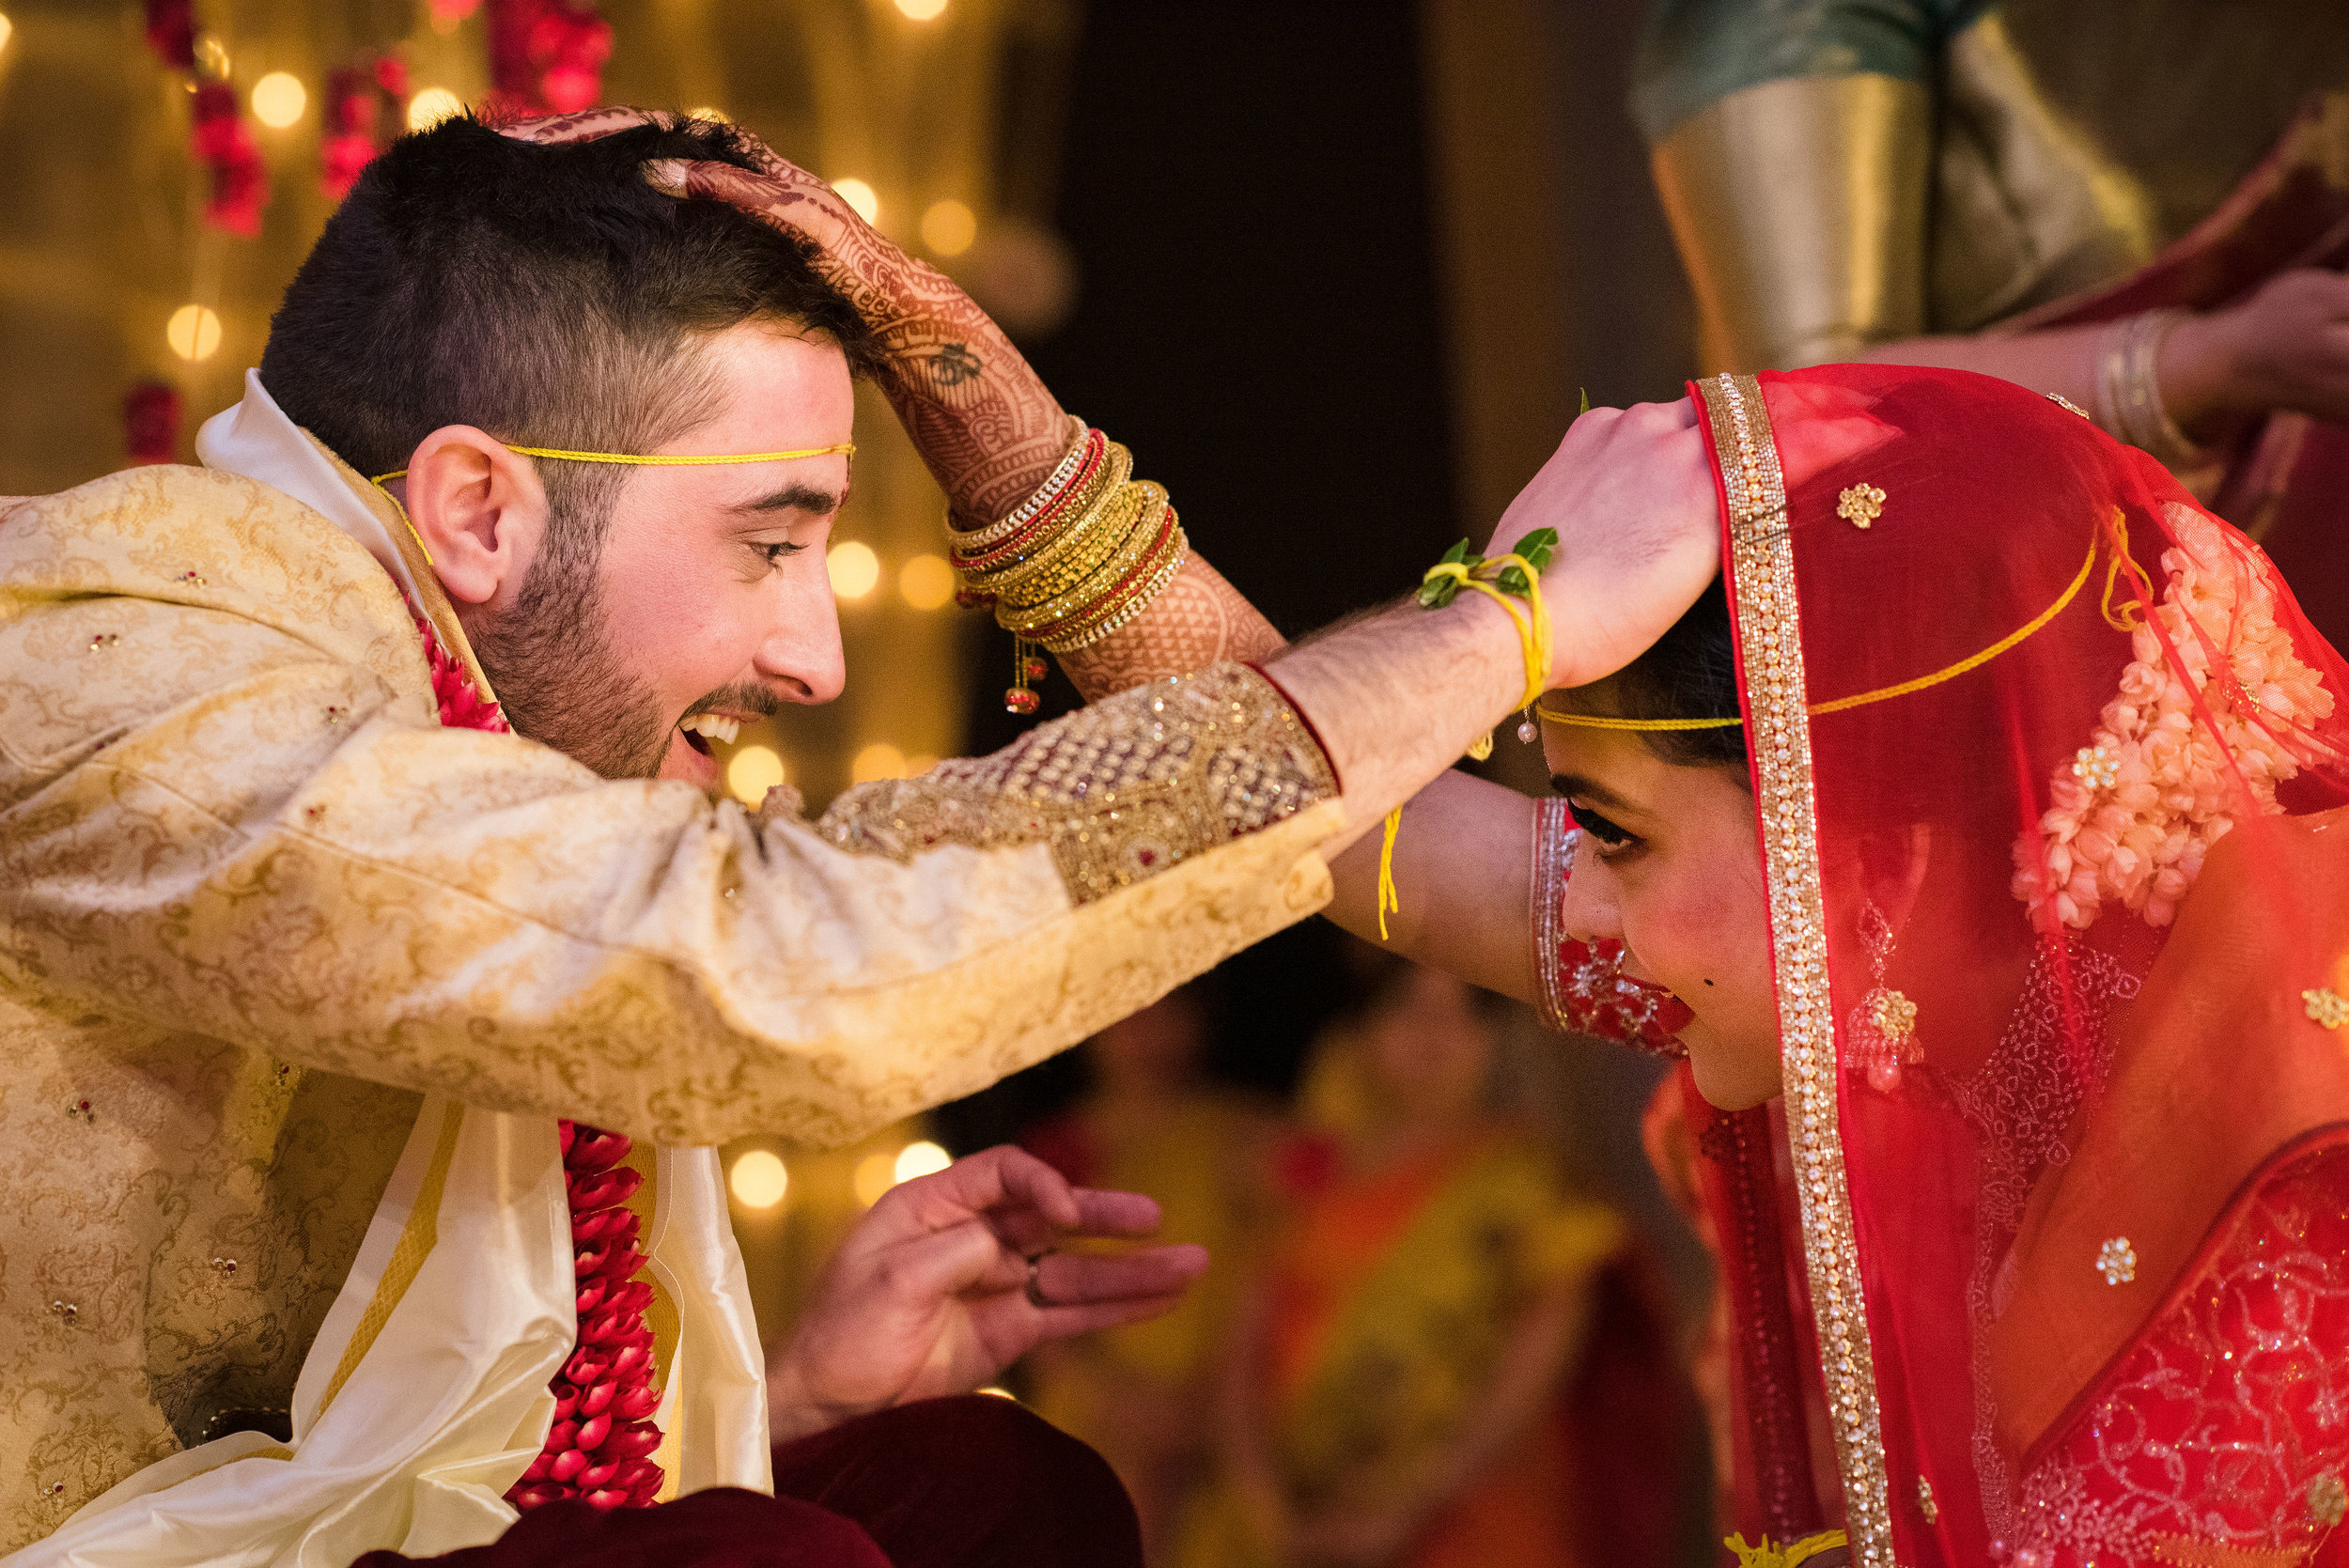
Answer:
(409, 606, 665, 1514)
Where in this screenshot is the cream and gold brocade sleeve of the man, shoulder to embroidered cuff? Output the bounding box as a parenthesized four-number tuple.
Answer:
(0, 470, 1342, 1143)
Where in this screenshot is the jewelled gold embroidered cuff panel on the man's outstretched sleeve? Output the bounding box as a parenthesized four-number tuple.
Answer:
(816, 664, 1337, 904)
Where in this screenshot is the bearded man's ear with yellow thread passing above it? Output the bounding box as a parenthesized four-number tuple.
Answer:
(397, 425, 548, 608)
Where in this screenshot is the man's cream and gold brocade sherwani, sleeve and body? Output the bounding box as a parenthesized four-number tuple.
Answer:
(0, 467, 1344, 1552)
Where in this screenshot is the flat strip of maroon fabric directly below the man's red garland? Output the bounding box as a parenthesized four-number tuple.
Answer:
(352, 1486, 891, 1568)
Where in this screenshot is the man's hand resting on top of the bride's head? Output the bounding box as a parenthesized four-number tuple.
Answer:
(1485, 399, 1722, 686)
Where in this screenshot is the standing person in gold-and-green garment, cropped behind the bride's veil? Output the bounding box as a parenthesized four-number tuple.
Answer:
(1633, 0, 2349, 645)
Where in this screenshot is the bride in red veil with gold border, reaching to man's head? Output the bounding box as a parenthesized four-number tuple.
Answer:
(667, 119, 2349, 1568)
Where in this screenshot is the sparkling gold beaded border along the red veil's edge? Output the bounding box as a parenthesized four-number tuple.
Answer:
(1699, 376, 1893, 1568)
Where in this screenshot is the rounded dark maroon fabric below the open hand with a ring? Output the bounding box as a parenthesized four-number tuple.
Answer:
(770, 1394, 1142, 1568)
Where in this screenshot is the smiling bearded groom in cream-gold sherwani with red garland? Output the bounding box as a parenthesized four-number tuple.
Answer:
(0, 119, 1715, 1563)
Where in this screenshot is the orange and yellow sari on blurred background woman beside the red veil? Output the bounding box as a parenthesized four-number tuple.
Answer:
(1179, 1125, 1628, 1568)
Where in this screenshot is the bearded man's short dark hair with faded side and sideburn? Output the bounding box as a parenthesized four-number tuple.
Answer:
(261, 115, 877, 556)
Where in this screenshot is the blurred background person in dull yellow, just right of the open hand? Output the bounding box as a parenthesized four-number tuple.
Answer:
(1022, 988, 1281, 1561)
